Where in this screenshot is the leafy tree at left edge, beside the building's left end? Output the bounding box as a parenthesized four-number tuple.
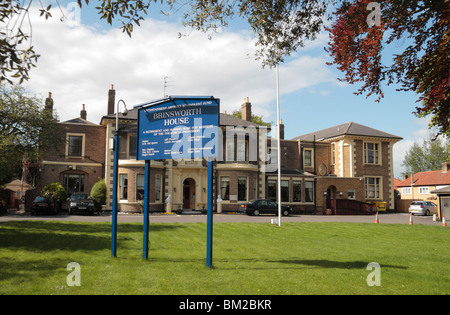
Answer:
(0, 86, 65, 184)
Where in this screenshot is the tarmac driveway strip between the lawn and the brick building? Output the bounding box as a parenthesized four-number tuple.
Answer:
(0, 210, 441, 225)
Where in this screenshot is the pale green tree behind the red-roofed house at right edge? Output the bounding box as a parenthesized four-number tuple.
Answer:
(402, 138, 450, 175)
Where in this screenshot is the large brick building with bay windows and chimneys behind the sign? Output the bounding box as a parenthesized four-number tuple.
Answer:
(37, 86, 401, 212)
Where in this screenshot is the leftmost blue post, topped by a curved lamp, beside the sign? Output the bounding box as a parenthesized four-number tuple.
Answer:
(111, 100, 128, 257)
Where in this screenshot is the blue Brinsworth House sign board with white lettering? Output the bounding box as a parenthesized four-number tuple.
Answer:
(136, 96, 220, 160)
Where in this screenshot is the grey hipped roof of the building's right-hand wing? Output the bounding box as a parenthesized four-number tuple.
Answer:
(292, 122, 402, 141)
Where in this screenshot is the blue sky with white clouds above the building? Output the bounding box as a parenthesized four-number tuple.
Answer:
(20, 0, 440, 178)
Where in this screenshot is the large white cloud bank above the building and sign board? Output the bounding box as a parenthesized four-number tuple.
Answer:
(21, 8, 333, 123)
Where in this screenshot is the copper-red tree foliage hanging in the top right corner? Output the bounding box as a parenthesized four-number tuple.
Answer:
(326, 0, 450, 135)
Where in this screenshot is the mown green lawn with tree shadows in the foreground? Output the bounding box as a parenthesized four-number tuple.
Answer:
(0, 221, 450, 295)
